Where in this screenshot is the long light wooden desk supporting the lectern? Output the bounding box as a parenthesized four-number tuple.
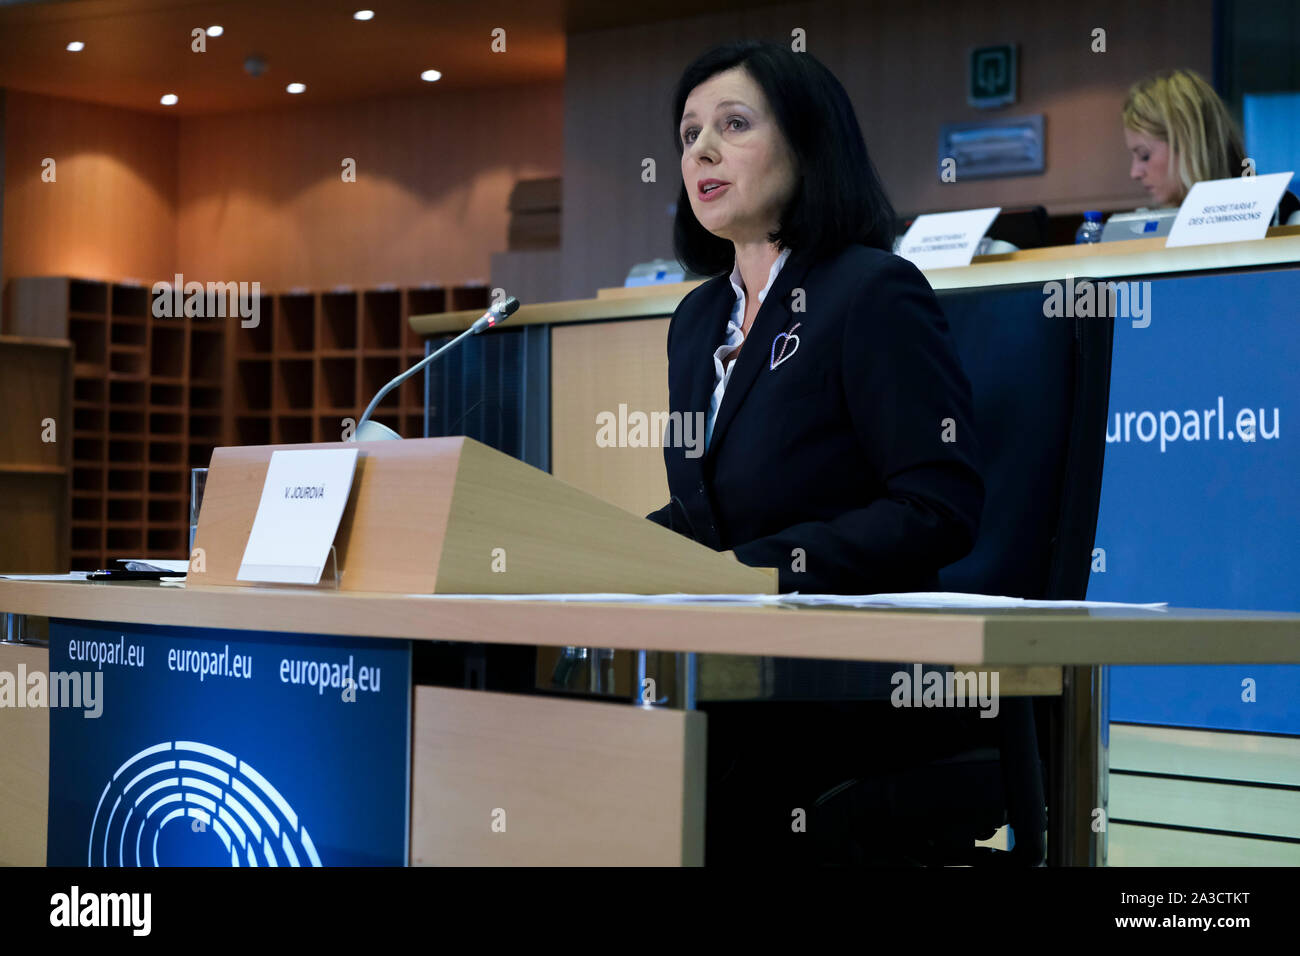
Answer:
(0, 580, 1300, 862)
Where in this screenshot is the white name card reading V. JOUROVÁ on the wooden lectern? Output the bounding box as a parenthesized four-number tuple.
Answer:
(235, 449, 359, 584)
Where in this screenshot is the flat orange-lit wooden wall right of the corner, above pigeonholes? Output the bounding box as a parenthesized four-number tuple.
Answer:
(177, 85, 563, 291)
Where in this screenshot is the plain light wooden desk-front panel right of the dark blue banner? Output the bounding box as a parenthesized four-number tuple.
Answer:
(411, 687, 707, 866)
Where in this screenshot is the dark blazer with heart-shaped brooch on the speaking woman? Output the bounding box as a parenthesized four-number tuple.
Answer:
(647, 245, 984, 594)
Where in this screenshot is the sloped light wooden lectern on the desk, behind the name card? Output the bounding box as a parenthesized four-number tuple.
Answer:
(187, 437, 777, 594)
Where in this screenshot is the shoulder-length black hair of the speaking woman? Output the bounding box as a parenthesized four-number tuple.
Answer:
(672, 40, 896, 276)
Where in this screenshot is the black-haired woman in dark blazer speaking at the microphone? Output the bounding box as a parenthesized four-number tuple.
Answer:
(647, 42, 984, 594)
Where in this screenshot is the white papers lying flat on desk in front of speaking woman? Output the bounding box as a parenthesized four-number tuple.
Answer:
(419, 591, 1169, 610)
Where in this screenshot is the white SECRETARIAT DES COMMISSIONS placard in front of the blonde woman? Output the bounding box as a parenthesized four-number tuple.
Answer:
(1165, 173, 1295, 246)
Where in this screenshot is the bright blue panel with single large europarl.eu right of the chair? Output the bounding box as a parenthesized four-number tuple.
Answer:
(1088, 271, 1300, 734)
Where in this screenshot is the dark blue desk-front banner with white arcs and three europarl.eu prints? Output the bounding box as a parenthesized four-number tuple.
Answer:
(47, 620, 411, 866)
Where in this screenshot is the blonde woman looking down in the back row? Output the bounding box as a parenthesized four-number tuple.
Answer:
(1123, 70, 1300, 224)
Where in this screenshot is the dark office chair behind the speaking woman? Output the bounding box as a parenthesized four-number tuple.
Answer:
(809, 280, 1114, 866)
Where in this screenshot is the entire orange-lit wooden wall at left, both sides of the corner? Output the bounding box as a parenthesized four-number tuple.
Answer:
(0, 85, 563, 291)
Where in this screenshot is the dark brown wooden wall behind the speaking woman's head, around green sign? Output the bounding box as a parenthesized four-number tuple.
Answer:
(563, 0, 1213, 299)
